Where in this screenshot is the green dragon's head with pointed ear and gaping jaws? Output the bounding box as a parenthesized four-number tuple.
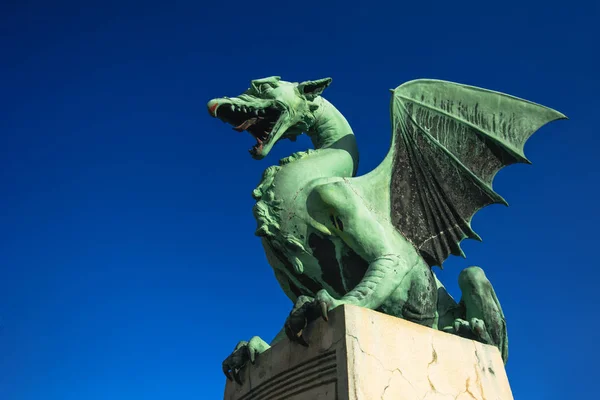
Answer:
(207, 76, 331, 160)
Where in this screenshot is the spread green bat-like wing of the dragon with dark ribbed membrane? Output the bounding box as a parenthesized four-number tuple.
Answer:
(390, 80, 566, 266)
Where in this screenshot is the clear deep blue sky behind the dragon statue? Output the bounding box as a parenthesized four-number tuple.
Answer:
(0, 0, 600, 400)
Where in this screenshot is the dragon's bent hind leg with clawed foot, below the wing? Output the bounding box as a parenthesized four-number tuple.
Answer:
(443, 267, 508, 363)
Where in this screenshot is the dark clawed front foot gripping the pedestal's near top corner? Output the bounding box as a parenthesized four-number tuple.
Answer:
(285, 290, 341, 347)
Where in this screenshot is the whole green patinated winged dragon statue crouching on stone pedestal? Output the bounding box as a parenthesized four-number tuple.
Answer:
(208, 76, 566, 383)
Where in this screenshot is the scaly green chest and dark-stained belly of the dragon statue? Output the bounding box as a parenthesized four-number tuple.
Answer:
(253, 158, 367, 299)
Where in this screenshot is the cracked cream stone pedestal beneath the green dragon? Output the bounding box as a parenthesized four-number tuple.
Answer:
(225, 306, 513, 400)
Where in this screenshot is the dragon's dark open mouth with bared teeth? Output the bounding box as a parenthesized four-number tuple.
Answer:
(217, 104, 281, 155)
